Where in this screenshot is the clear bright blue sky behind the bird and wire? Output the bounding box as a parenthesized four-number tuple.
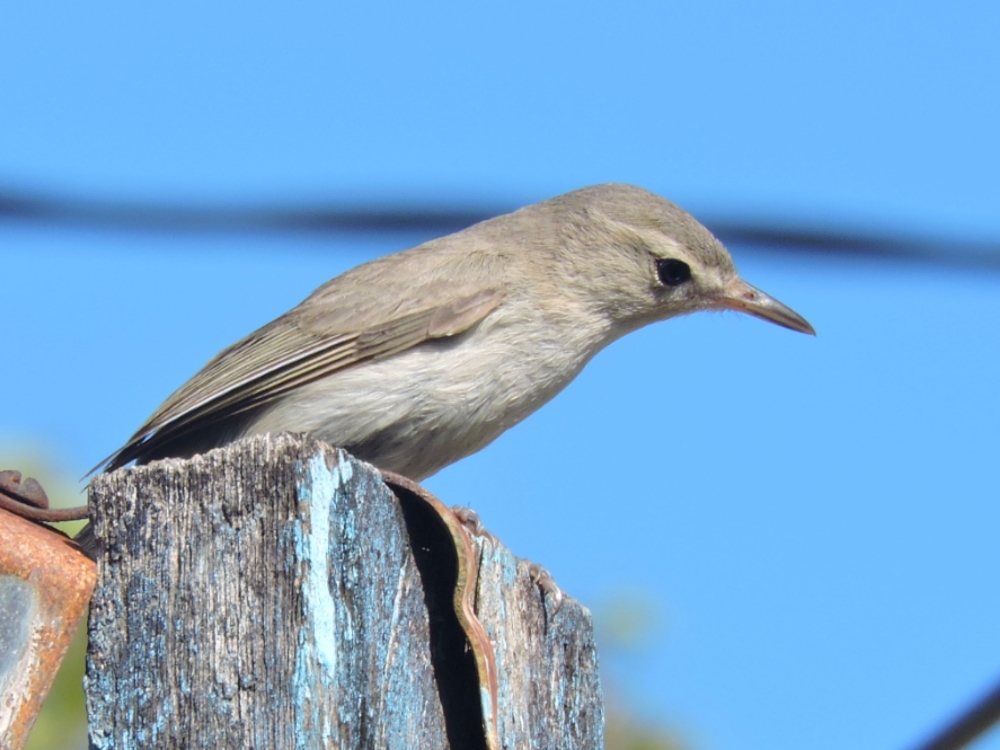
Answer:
(0, 2, 1000, 749)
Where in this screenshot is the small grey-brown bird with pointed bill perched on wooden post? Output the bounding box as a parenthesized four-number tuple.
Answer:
(95, 185, 815, 480)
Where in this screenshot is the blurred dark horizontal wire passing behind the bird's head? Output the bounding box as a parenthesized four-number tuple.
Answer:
(0, 188, 1000, 271)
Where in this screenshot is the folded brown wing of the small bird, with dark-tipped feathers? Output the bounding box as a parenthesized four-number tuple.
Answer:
(96, 289, 503, 470)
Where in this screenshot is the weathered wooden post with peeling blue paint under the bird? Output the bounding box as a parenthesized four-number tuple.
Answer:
(86, 435, 603, 750)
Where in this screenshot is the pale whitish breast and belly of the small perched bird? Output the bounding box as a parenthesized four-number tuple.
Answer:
(246, 320, 599, 480)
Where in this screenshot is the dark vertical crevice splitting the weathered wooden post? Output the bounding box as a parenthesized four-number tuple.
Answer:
(393, 486, 487, 750)
